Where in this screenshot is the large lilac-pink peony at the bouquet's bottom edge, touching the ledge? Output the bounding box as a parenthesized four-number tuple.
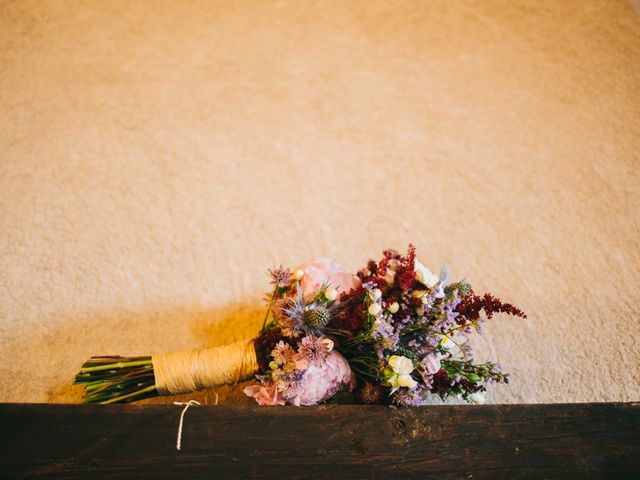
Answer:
(291, 350, 356, 405)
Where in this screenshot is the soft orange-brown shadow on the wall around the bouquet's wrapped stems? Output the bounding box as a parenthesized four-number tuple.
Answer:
(43, 301, 265, 404)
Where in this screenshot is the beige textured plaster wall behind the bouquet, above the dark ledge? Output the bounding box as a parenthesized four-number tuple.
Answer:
(0, 0, 640, 402)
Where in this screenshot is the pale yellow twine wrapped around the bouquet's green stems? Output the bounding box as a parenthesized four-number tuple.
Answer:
(151, 340, 258, 395)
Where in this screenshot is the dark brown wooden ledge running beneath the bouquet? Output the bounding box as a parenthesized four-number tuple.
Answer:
(0, 403, 640, 480)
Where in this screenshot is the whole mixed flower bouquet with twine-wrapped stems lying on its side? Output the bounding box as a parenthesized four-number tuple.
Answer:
(76, 245, 526, 406)
